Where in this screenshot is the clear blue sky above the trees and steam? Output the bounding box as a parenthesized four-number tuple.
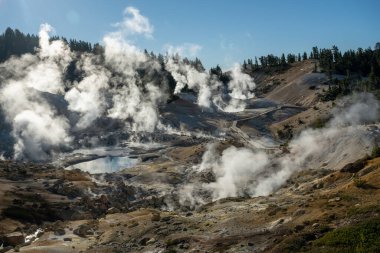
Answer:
(0, 0, 380, 68)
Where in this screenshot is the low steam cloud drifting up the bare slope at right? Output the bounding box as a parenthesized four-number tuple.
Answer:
(180, 94, 379, 206)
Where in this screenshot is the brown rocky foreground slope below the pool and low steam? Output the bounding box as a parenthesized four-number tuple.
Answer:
(0, 143, 380, 252)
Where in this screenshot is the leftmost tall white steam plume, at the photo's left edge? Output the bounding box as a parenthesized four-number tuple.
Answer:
(0, 24, 71, 160)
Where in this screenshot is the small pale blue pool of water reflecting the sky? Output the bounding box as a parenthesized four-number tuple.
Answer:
(66, 156, 138, 174)
